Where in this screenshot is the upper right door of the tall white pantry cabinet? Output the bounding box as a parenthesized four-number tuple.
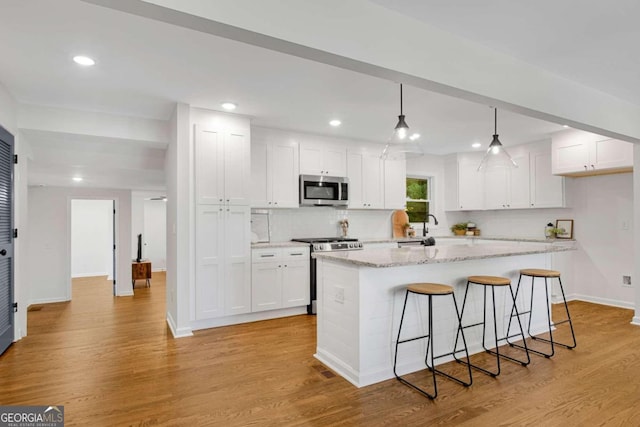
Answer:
(224, 132, 251, 206)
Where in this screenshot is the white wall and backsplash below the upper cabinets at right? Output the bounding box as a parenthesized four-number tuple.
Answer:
(447, 173, 635, 308)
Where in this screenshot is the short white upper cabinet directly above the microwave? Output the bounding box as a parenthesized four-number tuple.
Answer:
(300, 141, 347, 176)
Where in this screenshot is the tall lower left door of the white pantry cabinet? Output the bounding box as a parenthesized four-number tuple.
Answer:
(195, 205, 225, 320)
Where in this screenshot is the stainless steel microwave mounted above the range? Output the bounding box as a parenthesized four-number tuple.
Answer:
(300, 175, 349, 206)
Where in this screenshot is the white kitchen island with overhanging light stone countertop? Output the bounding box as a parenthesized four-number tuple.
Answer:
(315, 242, 573, 387)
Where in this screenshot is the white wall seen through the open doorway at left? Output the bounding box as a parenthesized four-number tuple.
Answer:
(71, 199, 113, 278)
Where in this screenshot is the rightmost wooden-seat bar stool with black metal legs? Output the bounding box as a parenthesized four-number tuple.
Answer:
(509, 268, 577, 358)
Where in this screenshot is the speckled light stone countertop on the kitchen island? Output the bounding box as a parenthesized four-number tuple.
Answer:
(313, 243, 575, 268)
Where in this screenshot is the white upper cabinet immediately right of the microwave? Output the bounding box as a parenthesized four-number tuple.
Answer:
(347, 151, 384, 209)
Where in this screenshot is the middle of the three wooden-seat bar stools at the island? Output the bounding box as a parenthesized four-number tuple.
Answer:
(456, 276, 531, 377)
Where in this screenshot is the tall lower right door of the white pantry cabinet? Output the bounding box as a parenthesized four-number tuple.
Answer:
(224, 205, 251, 315)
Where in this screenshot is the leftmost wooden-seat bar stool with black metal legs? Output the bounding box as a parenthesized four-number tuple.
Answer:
(393, 283, 473, 399)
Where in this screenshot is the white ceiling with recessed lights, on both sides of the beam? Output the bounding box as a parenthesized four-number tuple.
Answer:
(0, 0, 640, 189)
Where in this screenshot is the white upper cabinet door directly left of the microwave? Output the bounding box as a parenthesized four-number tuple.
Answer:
(269, 142, 300, 208)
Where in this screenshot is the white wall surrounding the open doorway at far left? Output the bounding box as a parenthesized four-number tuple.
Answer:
(27, 187, 133, 304)
